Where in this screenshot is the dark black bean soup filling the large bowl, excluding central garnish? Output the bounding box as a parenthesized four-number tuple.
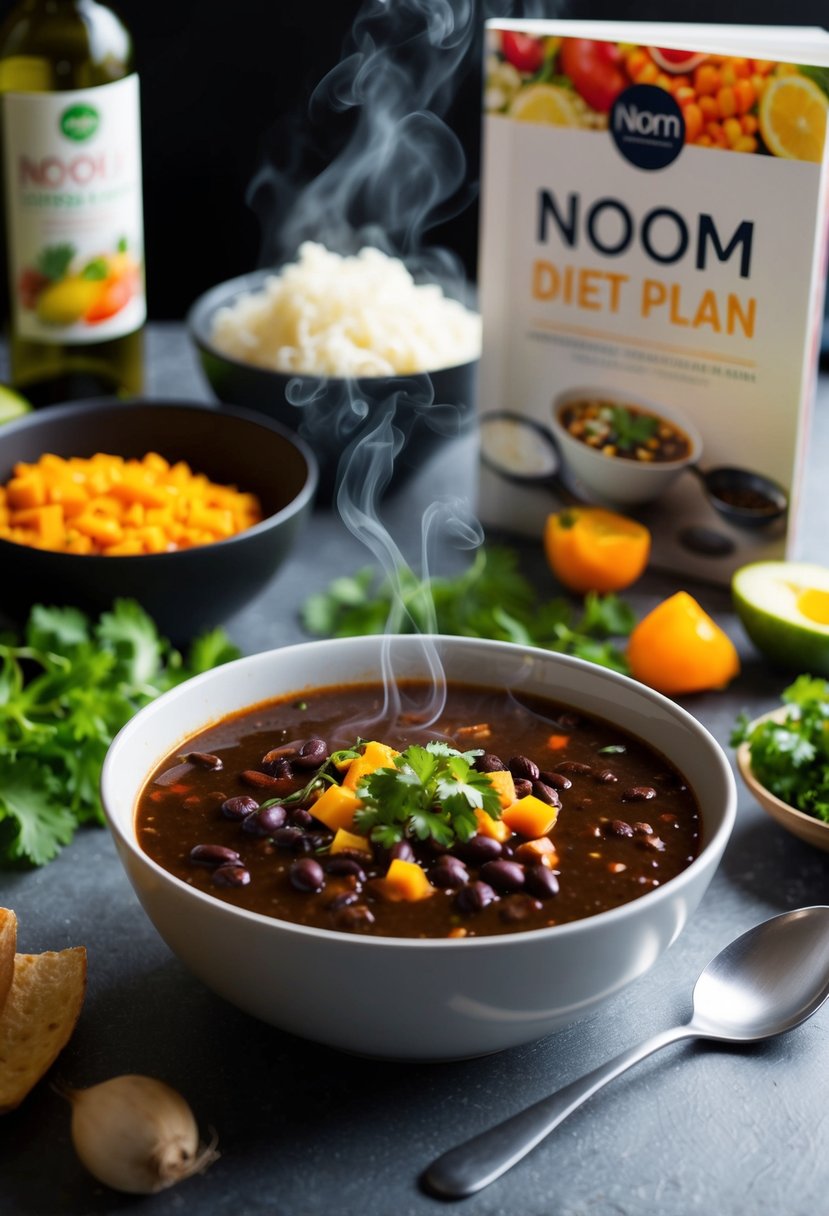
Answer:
(136, 683, 701, 938)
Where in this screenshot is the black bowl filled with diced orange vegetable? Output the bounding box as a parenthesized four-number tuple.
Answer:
(0, 399, 317, 641)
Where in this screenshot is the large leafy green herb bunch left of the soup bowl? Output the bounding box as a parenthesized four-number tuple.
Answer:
(0, 599, 238, 866)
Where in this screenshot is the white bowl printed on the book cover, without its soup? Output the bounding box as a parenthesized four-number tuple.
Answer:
(551, 387, 703, 506)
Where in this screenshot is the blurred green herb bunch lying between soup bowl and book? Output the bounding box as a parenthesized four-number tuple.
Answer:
(301, 546, 635, 674)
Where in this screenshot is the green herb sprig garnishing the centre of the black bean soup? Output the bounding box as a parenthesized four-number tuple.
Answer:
(354, 739, 501, 849)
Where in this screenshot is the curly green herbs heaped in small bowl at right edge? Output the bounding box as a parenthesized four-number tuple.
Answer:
(731, 675, 829, 823)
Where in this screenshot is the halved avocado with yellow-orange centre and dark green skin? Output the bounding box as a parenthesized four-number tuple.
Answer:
(732, 562, 829, 676)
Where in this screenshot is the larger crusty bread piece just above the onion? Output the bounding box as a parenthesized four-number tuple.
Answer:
(0, 946, 86, 1114)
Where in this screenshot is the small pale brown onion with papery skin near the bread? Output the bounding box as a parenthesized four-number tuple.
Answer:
(62, 1075, 219, 1195)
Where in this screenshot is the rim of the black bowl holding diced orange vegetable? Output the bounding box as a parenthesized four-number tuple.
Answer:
(0, 396, 320, 568)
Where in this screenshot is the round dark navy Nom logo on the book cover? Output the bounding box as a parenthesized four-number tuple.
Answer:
(610, 84, 686, 169)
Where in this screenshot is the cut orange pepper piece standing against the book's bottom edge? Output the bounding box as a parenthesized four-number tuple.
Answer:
(543, 507, 650, 595)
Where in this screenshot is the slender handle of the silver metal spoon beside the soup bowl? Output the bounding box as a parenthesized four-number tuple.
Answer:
(423, 1025, 699, 1199)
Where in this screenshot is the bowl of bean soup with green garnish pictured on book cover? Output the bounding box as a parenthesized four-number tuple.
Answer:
(551, 387, 703, 506)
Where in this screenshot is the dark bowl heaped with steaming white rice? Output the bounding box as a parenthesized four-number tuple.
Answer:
(187, 242, 480, 502)
